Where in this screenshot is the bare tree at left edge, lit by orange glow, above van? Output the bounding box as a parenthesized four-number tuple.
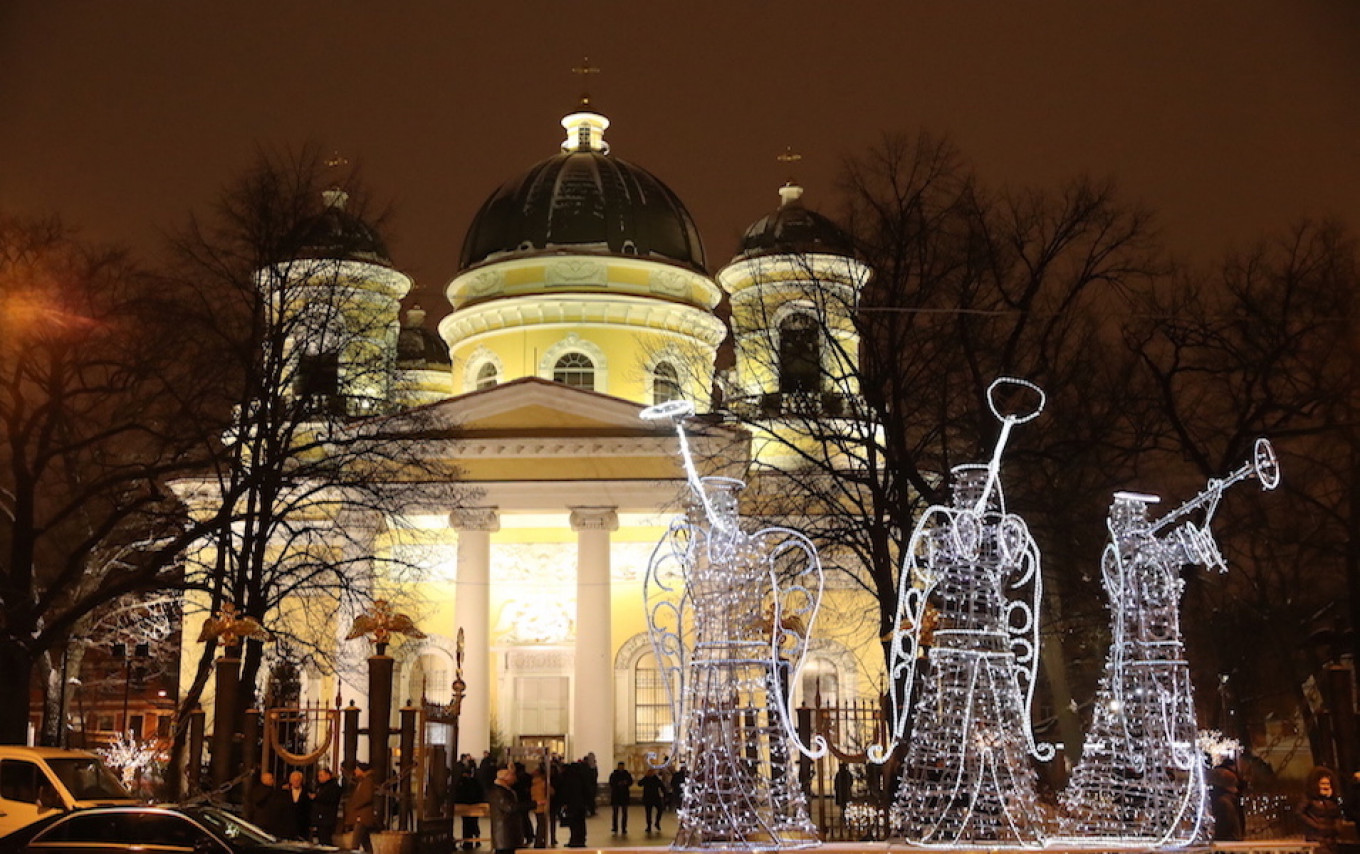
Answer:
(0, 218, 213, 742)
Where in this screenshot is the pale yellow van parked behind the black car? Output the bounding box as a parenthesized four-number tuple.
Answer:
(0, 745, 137, 835)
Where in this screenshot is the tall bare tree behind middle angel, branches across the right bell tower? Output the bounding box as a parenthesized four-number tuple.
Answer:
(707, 135, 1163, 749)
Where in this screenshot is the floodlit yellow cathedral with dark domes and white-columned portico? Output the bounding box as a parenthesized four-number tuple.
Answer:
(185, 103, 881, 767)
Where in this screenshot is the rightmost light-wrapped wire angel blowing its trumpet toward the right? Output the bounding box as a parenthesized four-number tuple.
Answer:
(1062, 439, 1280, 847)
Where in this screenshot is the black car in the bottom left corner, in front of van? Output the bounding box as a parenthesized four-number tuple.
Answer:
(0, 806, 340, 854)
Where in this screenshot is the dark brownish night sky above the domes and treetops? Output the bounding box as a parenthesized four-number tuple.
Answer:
(0, 0, 1360, 310)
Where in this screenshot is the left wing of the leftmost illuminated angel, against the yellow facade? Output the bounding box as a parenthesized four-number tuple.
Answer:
(642, 518, 706, 768)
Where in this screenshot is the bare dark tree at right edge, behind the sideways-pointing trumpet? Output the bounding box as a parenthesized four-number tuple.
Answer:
(1129, 222, 1360, 762)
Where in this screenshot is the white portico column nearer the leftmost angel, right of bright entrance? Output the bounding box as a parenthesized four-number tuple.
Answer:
(571, 507, 619, 770)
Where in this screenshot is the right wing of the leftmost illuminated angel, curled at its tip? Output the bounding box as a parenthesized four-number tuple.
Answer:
(751, 528, 828, 759)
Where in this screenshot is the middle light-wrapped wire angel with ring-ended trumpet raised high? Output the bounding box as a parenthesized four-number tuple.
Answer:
(870, 378, 1054, 846)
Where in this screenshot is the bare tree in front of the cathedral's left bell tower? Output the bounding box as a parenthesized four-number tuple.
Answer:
(160, 150, 457, 794)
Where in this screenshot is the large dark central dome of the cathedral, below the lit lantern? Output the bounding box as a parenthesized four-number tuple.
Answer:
(461, 150, 706, 272)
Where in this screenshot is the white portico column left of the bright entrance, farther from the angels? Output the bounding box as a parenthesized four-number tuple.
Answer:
(449, 507, 500, 759)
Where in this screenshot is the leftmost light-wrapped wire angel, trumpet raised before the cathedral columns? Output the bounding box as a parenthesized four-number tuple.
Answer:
(642, 401, 827, 850)
